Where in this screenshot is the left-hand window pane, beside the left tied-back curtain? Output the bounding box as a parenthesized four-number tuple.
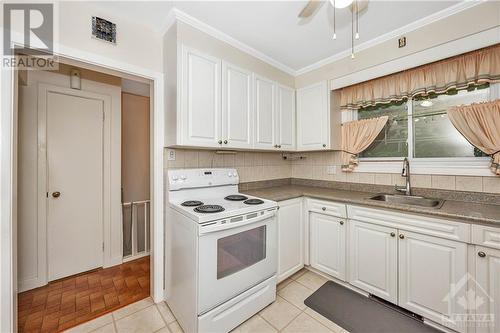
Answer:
(358, 103, 408, 157)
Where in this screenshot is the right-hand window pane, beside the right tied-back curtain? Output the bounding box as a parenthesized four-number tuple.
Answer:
(412, 88, 489, 158)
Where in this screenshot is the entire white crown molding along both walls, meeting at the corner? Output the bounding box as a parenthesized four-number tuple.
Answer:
(159, 0, 488, 77)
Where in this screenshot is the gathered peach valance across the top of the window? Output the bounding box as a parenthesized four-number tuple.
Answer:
(340, 44, 500, 109)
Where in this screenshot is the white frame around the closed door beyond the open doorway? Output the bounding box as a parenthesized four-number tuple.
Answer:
(37, 83, 110, 287)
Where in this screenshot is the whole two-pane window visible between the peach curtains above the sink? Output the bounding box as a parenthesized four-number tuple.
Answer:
(358, 87, 490, 159)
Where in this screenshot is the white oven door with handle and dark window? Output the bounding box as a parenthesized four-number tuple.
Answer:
(198, 210, 278, 315)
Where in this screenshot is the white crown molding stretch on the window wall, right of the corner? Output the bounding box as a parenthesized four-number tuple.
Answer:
(295, 0, 487, 76)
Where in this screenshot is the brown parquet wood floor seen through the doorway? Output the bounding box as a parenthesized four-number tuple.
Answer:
(17, 256, 150, 333)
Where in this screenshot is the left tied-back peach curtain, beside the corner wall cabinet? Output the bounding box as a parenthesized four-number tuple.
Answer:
(342, 116, 389, 172)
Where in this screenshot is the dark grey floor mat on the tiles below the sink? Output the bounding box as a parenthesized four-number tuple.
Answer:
(304, 281, 442, 333)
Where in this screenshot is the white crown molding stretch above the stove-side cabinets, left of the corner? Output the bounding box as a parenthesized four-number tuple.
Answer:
(161, 8, 297, 76)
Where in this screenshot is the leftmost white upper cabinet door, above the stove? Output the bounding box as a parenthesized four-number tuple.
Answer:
(180, 47, 222, 147)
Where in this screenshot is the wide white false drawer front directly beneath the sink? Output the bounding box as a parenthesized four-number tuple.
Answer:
(347, 205, 471, 243)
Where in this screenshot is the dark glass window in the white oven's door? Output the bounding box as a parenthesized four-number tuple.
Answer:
(217, 225, 266, 280)
